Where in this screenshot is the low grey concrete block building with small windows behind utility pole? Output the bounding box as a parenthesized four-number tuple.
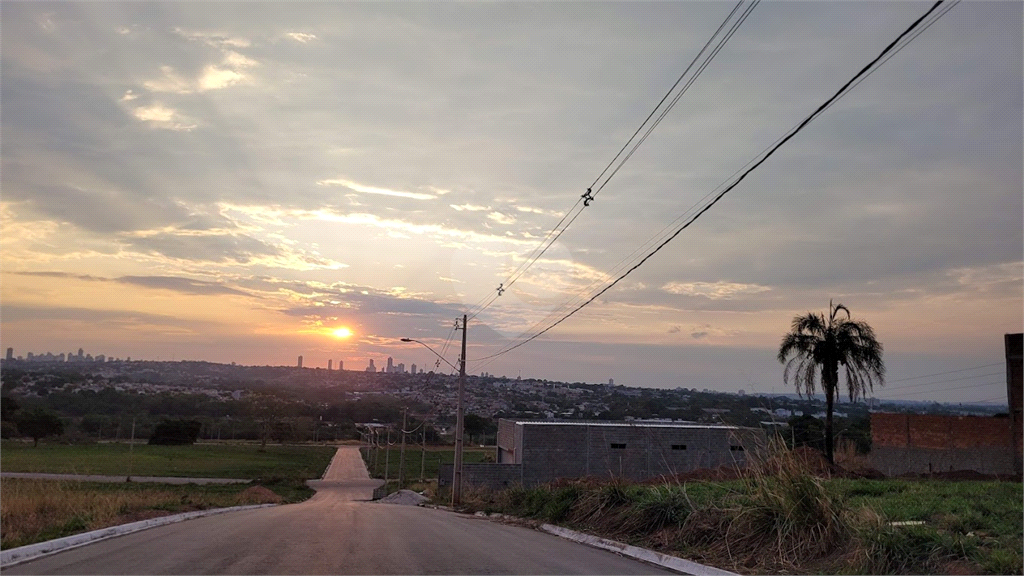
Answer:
(439, 418, 765, 488)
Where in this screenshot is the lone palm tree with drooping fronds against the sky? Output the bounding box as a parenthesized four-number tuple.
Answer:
(778, 300, 886, 462)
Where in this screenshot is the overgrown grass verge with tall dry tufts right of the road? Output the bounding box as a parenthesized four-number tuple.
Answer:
(452, 440, 1024, 574)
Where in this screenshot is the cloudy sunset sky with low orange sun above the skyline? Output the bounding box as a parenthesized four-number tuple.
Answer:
(0, 1, 1024, 402)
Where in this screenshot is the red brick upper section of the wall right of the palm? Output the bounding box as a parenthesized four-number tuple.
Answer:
(871, 413, 1013, 450)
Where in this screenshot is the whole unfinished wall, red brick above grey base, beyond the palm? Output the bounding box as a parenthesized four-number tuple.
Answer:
(868, 413, 1019, 476)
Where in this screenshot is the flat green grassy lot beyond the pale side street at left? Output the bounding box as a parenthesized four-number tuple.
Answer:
(0, 441, 335, 479)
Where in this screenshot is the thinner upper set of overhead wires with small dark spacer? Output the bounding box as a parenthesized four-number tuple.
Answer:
(467, 0, 760, 318)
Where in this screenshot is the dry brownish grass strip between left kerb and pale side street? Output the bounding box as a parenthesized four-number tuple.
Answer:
(0, 479, 313, 549)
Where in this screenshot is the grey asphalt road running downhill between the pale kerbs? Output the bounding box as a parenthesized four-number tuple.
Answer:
(4, 447, 671, 574)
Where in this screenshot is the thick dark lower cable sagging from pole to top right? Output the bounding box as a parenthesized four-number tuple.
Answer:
(470, 0, 958, 362)
